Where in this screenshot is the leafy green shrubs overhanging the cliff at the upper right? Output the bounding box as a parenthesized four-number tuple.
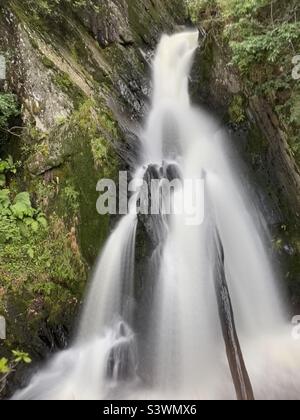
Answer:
(187, 0, 300, 156)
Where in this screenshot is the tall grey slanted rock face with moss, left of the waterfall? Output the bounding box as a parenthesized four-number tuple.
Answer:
(0, 0, 185, 396)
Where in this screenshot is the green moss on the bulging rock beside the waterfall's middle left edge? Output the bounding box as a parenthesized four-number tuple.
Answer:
(48, 100, 120, 264)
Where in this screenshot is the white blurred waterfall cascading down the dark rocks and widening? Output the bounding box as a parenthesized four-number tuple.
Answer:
(15, 32, 300, 399)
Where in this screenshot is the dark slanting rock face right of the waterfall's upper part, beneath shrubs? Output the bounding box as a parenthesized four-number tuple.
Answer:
(194, 40, 300, 212)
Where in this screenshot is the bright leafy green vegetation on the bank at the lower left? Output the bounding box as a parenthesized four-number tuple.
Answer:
(0, 151, 85, 374)
